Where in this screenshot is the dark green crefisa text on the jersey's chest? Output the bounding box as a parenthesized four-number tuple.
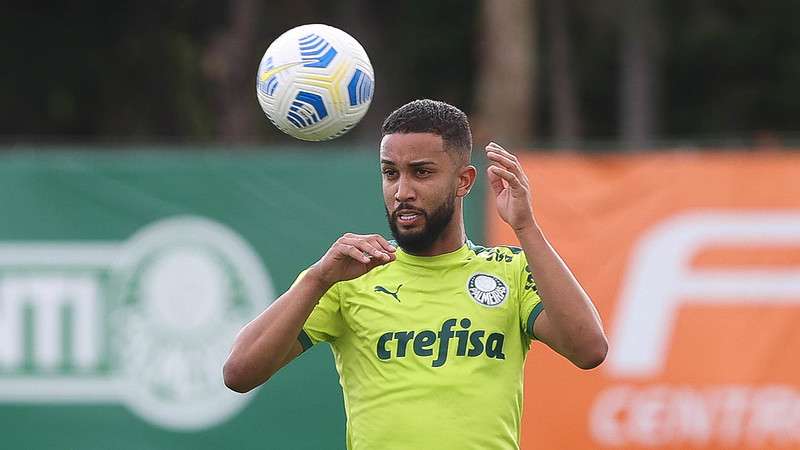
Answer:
(376, 318, 506, 367)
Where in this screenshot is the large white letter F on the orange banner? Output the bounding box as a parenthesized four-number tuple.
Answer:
(604, 211, 800, 377)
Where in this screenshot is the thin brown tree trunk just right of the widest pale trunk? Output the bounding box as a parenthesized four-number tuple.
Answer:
(545, 0, 580, 149)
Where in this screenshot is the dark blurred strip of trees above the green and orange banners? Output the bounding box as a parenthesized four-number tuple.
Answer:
(6, 0, 800, 150)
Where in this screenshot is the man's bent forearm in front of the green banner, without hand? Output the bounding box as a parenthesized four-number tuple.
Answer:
(223, 276, 329, 392)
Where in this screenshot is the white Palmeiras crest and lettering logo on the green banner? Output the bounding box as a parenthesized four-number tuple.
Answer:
(0, 217, 273, 431)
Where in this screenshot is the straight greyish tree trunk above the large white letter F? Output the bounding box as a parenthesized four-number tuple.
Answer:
(620, 0, 660, 150)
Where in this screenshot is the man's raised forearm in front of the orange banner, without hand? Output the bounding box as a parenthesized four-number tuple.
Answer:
(517, 222, 607, 367)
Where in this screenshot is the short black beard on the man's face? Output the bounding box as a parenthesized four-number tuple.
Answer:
(386, 193, 456, 254)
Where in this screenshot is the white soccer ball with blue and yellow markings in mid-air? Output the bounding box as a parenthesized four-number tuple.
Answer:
(256, 24, 375, 141)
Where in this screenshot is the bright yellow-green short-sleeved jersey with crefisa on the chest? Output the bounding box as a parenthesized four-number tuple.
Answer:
(299, 242, 542, 450)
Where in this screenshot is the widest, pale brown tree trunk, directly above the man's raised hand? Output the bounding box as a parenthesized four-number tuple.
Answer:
(473, 0, 536, 148)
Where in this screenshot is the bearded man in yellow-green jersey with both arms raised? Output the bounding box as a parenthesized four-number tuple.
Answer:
(224, 100, 607, 450)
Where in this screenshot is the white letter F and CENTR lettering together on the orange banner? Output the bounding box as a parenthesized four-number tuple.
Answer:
(589, 211, 800, 448)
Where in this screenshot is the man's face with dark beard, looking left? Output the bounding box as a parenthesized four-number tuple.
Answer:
(381, 133, 458, 253)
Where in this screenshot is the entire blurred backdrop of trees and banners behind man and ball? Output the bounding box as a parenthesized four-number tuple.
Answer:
(0, 0, 800, 450)
